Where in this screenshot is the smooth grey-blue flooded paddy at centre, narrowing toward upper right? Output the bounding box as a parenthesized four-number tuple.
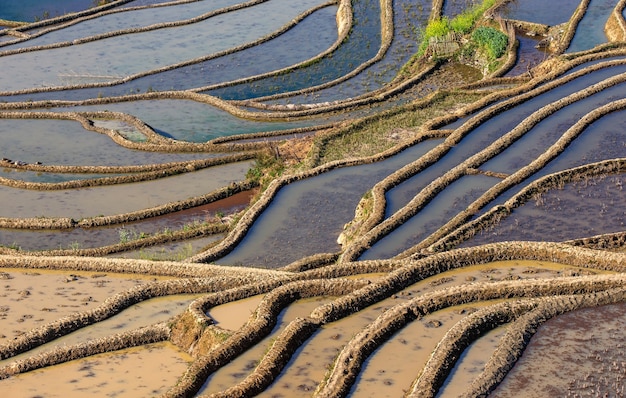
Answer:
(216, 140, 441, 268)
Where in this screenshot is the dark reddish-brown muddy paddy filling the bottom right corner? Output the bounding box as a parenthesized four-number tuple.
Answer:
(490, 303, 626, 398)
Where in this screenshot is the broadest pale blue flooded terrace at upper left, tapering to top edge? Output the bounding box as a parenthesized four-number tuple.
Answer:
(0, 0, 321, 91)
